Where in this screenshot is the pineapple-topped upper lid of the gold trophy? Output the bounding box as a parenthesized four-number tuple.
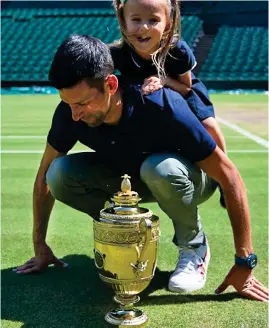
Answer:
(111, 174, 141, 207)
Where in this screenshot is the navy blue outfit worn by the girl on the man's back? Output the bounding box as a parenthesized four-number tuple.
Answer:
(110, 41, 215, 121)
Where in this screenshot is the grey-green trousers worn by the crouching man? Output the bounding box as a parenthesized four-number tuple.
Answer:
(46, 152, 217, 246)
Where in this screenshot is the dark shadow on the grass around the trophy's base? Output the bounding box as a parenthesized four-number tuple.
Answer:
(1, 255, 242, 328)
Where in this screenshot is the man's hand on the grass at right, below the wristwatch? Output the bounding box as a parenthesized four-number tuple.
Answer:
(215, 264, 269, 303)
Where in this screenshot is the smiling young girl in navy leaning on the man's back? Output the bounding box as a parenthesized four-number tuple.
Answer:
(111, 0, 226, 205)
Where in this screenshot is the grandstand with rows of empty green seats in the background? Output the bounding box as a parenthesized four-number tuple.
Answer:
(1, 1, 268, 90)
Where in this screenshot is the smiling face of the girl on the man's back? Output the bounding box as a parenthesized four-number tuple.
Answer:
(124, 0, 169, 59)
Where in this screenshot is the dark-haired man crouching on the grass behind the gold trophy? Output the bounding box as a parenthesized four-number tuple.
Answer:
(17, 36, 268, 302)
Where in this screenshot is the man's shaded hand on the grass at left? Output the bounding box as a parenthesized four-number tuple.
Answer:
(13, 245, 68, 274)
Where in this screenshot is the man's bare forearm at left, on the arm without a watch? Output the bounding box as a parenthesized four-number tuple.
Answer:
(33, 179, 54, 255)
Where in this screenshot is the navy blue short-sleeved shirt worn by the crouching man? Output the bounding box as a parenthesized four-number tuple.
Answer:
(47, 81, 216, 173)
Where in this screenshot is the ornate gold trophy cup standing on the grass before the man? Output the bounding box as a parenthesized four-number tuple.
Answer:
(93, 174, 160, 328)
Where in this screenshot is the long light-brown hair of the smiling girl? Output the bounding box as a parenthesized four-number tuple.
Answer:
(113, 0, 181, 78)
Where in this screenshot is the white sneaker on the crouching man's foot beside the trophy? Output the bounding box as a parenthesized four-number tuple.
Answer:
(168, 238, 210, 293)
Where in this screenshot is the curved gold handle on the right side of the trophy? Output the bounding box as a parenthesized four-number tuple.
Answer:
(131, 218, 152, 277)
